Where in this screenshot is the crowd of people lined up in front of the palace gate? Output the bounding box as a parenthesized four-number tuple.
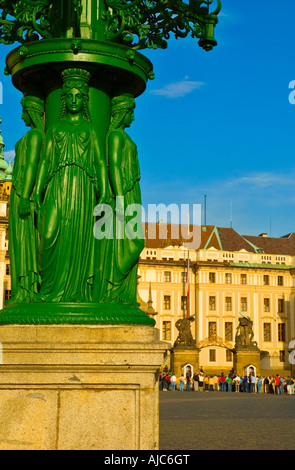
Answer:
(159, 366, 295, 395)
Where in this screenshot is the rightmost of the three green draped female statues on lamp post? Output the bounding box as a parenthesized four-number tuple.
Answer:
(95, 95, 144, 305)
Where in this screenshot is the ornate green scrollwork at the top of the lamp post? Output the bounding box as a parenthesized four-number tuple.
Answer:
(0, 0, 221, 51)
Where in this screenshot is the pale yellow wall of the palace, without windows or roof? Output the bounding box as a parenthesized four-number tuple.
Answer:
(139, 249, 295, 370)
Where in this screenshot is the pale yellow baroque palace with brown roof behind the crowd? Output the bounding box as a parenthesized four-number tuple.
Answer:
(138, 224, 295, 375)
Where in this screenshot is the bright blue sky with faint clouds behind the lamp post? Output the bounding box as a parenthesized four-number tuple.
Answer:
(0, 0, 295, 237)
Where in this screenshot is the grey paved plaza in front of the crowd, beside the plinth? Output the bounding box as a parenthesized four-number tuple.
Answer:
(159, 391, 295, 450)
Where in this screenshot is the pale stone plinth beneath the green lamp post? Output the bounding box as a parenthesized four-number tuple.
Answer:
(0, 325, 167, 450)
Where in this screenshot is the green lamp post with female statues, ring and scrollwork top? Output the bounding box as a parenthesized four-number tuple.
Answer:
(0, 0, 221, 325)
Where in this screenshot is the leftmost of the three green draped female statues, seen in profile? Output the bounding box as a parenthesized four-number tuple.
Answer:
(7, 96, 45, 303)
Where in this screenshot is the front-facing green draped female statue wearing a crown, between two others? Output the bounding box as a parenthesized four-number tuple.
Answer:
(36, 69, 107, 303)
